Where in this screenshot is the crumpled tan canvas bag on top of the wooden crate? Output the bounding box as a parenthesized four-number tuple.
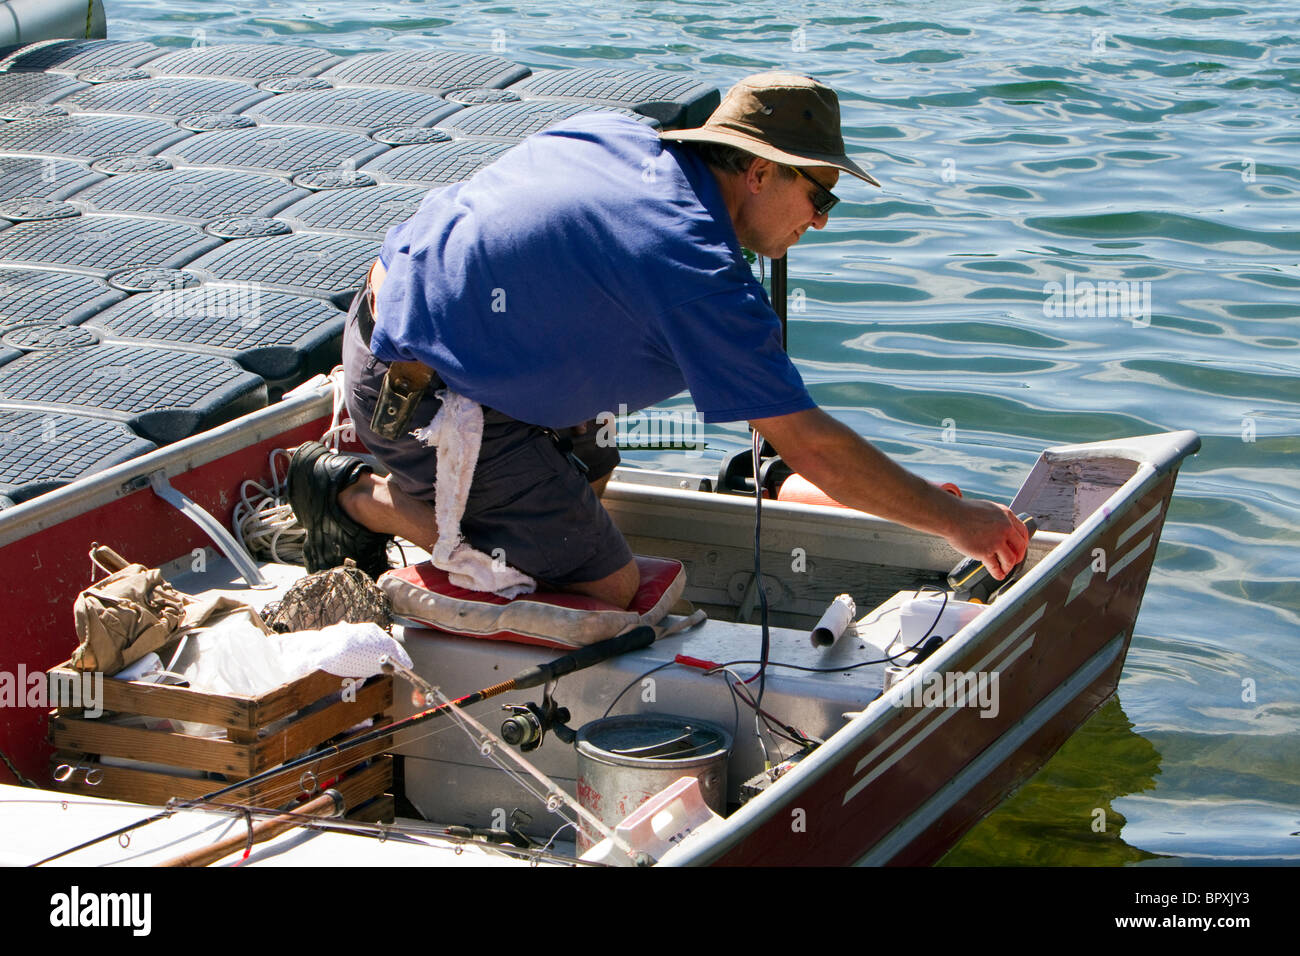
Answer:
(72, 545, 269, 675)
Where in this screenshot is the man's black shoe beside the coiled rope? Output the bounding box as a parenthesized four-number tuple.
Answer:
(289, 441, 393, 578)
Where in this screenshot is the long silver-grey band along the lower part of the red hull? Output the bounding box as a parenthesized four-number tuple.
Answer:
(854, 631, 1125, 866)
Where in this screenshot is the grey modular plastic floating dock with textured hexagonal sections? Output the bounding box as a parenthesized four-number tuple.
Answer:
(0, 39, 719, 507)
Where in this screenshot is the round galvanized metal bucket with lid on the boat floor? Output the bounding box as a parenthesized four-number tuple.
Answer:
(575, 714, 732, 853)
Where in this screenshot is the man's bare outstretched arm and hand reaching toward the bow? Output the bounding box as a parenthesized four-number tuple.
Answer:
(750, 408, 1028, 580)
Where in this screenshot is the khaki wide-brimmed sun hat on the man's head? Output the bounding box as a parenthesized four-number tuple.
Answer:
(659, 73, 880, 186)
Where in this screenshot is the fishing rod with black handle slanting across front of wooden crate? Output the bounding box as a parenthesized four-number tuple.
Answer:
(33, 611, 703, 866)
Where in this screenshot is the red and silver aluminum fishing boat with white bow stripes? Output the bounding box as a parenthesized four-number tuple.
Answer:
(0, 385, 1200, 866)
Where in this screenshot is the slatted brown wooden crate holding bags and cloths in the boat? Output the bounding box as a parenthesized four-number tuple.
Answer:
(49, 663, 393, 806)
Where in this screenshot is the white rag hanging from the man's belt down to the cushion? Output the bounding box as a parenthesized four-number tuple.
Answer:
(413, 389, 537, 598)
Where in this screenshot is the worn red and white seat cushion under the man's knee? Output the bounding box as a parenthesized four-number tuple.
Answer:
(378, 557, 686, 648)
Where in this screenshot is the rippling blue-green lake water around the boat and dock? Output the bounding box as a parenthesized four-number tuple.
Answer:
(107, 0, 1300, 864)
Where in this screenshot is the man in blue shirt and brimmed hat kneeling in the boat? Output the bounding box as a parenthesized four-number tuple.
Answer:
(290, 73, 1028, 607)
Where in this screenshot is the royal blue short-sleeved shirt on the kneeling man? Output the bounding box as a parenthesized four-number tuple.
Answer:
(371, 113, 814, 428)
